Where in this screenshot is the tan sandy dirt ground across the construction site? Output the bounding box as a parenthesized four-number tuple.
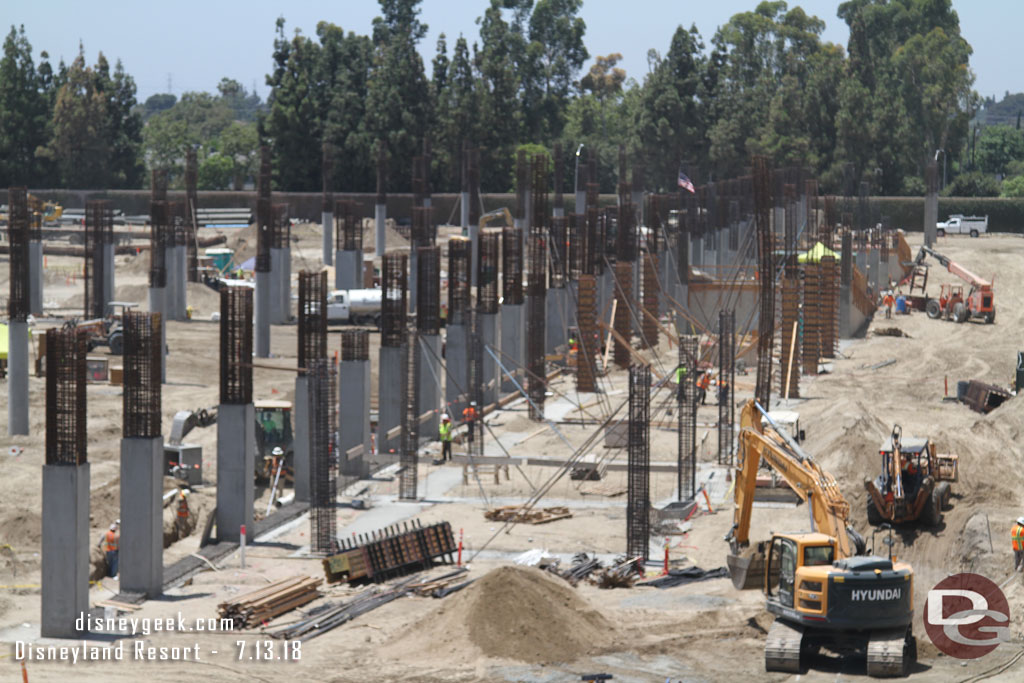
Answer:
(0, 225, 1024, 682)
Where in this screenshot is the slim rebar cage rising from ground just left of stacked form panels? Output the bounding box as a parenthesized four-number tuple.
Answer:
(300, 358, 338, 555)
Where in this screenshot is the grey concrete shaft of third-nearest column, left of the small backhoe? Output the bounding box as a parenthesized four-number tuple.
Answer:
(217, 403, 256, 543)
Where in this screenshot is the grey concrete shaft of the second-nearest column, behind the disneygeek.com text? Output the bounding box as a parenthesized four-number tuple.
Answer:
(118, 436, 164, 598)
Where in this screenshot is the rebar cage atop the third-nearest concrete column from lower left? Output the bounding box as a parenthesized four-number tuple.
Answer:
(220, 287, 253, 404)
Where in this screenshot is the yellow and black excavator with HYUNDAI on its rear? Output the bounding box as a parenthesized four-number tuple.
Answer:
(726, 400, 916, 677)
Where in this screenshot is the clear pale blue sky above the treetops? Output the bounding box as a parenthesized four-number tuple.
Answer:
(6, 0, 1024, 101)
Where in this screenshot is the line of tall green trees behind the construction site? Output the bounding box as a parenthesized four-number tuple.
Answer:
(0, 0, 991, 195)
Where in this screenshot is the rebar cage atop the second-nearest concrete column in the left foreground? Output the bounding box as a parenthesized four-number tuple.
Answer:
(122, 310, 164, 438)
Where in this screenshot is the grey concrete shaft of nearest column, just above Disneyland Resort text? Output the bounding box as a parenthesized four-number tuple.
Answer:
(39, 463, 89, 638)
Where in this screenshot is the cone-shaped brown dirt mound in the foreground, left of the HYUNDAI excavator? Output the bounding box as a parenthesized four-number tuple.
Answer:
(394, 566, 614, 664)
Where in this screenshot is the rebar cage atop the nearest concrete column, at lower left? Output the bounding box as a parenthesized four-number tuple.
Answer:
(46, 328, 88, 465)
